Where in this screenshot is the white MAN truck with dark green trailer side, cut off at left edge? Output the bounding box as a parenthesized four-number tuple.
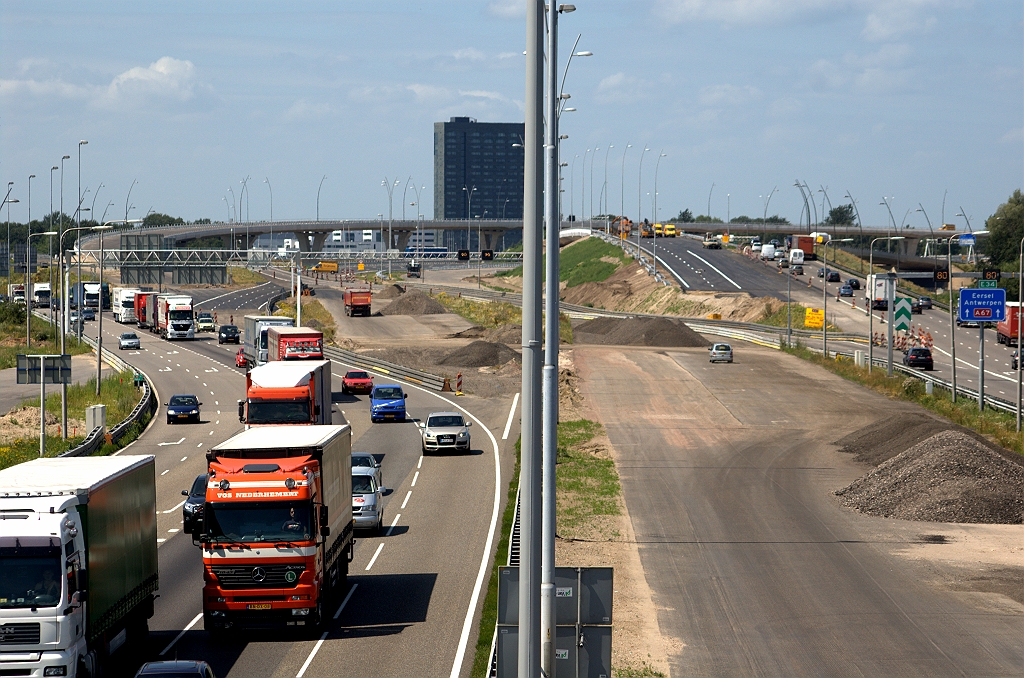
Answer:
(0, 455, 159, 678)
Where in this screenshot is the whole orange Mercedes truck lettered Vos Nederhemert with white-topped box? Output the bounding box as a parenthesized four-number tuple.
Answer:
(193, 424, 354, 634)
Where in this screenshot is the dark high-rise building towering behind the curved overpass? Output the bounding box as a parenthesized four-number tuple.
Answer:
(434, 118, 524, 219)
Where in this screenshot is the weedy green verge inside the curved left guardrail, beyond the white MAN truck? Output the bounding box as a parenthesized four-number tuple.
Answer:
(0, 373, 148, 468)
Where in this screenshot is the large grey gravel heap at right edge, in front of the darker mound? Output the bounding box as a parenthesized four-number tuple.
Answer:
(836, 431, 1024, 524)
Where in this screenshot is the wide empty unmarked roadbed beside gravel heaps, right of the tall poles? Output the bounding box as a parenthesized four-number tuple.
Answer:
(573, 345, 1024, 678)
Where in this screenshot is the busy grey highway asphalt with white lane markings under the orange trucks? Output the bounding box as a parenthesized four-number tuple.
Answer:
(77, 313, 517, 677)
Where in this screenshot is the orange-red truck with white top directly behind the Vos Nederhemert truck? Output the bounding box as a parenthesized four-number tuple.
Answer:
(239, 361, 332, 427)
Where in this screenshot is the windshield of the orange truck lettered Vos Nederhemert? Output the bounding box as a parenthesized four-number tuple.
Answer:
(205, 502, 311, 542)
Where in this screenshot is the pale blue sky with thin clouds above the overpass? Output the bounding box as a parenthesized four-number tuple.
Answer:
(0, 0, 1024, 228)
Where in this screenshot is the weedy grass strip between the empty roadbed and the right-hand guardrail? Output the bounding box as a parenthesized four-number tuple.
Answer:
(782, 344, 1024, 455)
